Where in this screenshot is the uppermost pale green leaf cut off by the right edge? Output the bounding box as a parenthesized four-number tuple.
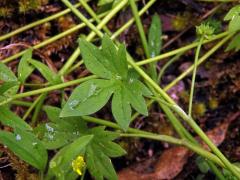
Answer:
(224, 5, 240, 31)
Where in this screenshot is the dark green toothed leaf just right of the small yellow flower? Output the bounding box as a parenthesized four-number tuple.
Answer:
(86, 127, 126, 180)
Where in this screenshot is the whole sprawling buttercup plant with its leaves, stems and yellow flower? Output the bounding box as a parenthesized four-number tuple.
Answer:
(0, 0, 240, 180)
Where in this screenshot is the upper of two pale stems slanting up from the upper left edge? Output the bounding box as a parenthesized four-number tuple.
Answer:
(0, 3, 80, 41)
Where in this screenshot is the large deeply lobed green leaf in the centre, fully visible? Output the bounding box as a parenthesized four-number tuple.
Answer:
(69, 36, 151, 130)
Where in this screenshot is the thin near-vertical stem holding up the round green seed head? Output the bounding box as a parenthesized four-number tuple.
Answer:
(188, 36, 204, 116)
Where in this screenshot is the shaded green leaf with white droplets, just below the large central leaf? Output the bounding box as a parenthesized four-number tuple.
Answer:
(34, 106, 87, 149)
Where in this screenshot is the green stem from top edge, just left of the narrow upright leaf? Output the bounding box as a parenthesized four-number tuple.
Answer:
(129, 0, 150, 58)
